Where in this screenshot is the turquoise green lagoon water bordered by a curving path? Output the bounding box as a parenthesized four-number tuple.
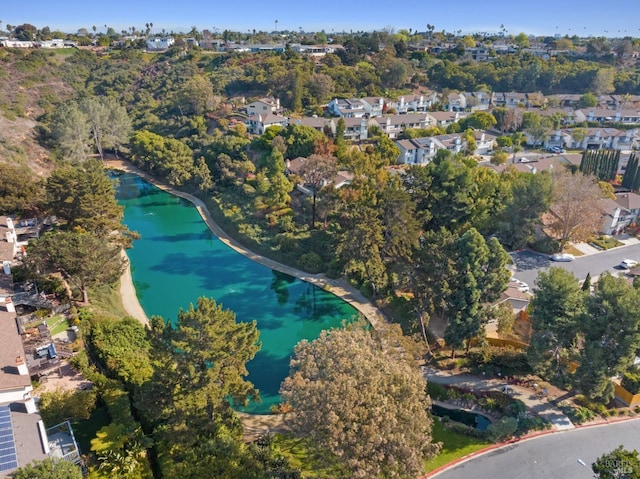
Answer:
(112, 173, 357, 413)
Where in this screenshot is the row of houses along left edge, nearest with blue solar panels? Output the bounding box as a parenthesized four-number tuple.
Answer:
(0, 217, 80, 477)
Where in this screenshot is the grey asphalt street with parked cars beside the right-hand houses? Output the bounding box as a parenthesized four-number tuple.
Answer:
(511, 244, 640, 289)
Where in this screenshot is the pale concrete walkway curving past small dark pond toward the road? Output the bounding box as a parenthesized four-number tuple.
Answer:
(423, 367, 575, 431)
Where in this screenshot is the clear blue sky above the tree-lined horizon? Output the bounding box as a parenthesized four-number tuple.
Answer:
(0, 0, 640, 37)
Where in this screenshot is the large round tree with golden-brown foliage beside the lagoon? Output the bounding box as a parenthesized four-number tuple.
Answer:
(281, 324, 437, 478)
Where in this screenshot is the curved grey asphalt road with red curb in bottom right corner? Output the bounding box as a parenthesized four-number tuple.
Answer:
(429, 419, 640, 479)
